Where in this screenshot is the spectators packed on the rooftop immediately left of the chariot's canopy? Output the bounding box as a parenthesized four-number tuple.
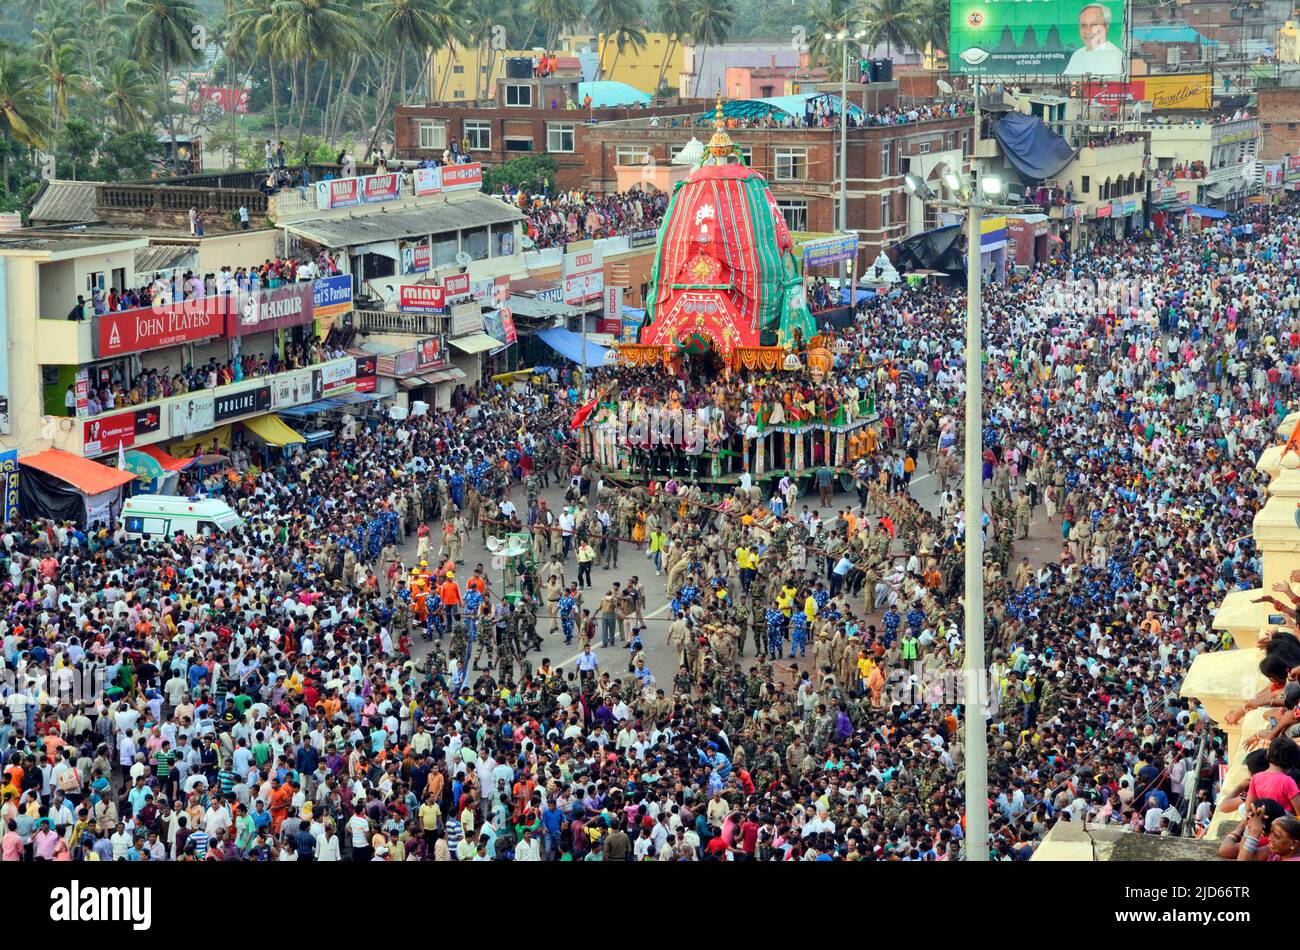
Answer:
(498, 186, 668, 250)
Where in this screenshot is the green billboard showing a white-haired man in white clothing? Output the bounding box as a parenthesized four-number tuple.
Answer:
(948, 0, 1127, 79)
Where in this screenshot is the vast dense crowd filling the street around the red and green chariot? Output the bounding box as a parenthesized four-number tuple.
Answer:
(0, 184, 1300, 860)
